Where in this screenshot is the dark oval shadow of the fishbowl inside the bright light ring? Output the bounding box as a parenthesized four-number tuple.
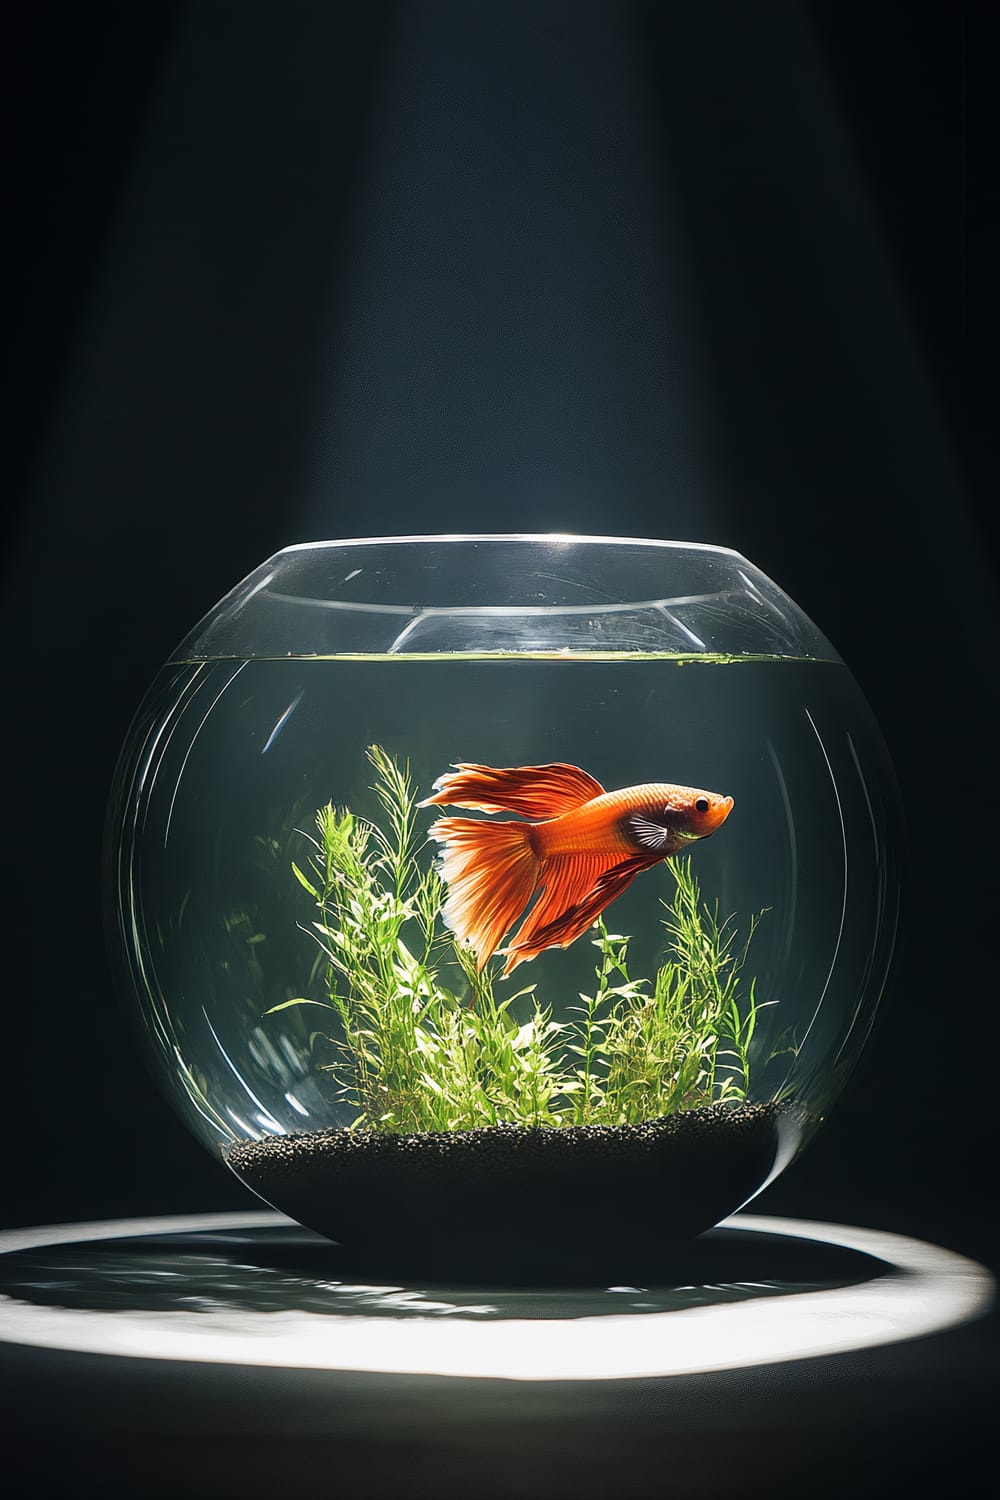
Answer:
(0, 1226, 889, 1322)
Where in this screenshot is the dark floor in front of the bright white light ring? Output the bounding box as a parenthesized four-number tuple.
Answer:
(0, 1206, 1000, 1500)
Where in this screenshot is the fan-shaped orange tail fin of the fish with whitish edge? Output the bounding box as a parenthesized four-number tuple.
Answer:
(429, 818, 541, 971)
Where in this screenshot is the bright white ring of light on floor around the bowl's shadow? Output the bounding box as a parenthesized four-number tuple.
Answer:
(0, 1212, 996, 1382)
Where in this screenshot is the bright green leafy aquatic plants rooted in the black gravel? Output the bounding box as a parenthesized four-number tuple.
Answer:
(267, 746, 760, 1133)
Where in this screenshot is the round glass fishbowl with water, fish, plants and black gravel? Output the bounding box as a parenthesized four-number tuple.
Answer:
(108, 536, 898, 1280)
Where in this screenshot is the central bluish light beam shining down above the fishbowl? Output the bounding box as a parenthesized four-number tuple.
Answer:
(301, 0, 711, 536)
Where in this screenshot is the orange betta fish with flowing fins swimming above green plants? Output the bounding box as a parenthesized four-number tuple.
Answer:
(418, 762, 733, 974)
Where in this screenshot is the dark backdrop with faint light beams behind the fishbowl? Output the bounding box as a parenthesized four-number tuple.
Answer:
(0, 0, 1000, 1260)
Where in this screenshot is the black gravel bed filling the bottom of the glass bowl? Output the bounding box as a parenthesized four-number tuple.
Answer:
(226, 1104, 799, 1284)
